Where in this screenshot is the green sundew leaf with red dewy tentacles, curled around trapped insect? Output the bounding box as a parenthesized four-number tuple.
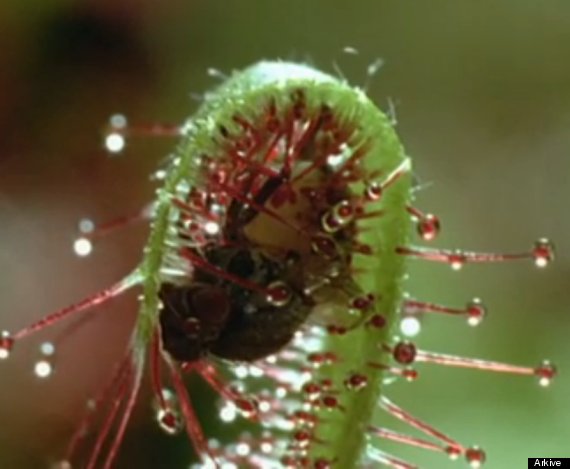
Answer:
(0, 62, 556, 469)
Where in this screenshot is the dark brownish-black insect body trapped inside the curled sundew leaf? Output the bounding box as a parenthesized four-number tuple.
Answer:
(160, 248, 311, 361)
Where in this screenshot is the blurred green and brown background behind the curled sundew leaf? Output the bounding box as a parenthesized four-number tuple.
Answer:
(0, 0, 570, 469)
